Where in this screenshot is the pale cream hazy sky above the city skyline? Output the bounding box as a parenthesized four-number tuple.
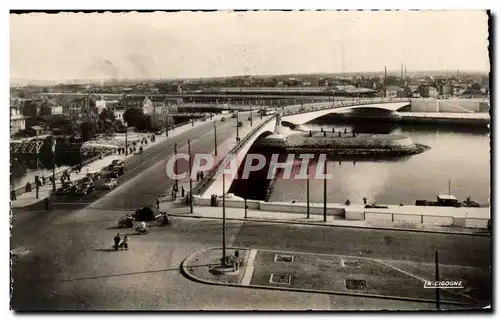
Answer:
(10, 11, 489, 80)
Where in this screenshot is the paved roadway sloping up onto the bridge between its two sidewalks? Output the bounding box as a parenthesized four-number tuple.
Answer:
(22, 113, 255, 210)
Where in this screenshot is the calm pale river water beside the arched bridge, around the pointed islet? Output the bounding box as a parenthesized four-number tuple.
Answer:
(232, 119, 490, 205)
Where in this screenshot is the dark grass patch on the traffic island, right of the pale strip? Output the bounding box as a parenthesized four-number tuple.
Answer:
(251, 250, 472, 302)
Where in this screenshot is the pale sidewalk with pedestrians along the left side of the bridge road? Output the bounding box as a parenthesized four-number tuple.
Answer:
(11, 116, 220, 208)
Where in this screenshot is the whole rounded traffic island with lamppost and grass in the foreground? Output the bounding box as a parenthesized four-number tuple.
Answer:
(182, 248, 482, 306)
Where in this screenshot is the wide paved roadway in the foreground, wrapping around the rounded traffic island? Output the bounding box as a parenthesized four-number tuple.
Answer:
(12, 210, 490, 310)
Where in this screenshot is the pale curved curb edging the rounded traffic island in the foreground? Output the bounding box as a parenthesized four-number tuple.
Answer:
(181, 247, 476, 306)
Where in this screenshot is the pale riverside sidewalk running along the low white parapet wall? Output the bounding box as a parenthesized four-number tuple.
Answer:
(160, 201, 490, 236)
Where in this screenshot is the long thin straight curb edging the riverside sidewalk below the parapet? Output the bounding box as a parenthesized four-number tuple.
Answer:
(169, 213, 491, 237)
